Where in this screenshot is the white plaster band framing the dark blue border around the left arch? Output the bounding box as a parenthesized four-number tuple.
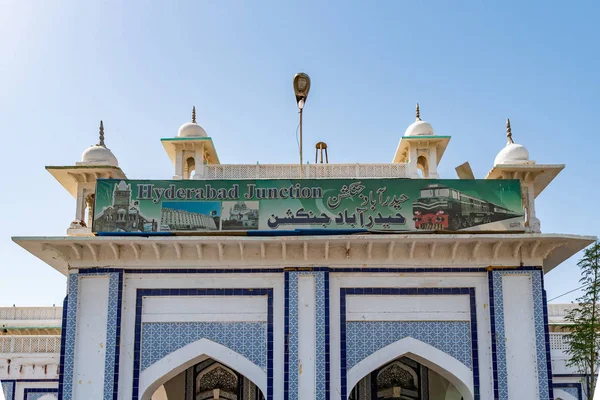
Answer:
(119, 273, 284, 399)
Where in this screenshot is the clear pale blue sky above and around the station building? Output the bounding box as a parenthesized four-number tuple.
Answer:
(0, 0, 600, 305)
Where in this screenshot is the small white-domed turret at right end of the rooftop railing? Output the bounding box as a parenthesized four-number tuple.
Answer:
(393, 103, 450, 178)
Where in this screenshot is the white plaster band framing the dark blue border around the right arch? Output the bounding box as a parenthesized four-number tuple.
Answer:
(330, 272, 494, 398)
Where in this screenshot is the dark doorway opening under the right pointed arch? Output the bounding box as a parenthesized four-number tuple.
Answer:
(348, 356, 464, 400)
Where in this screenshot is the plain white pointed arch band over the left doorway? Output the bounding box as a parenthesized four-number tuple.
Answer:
(139, 339, 267, 400)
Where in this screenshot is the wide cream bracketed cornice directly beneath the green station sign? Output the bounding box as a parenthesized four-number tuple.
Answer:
(13, 233, 595, 275)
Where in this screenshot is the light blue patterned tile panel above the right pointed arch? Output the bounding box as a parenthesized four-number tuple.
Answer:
(346, 321, 473, 369)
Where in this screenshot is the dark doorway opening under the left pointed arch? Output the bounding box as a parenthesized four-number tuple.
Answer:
(151, 358, 265, 400)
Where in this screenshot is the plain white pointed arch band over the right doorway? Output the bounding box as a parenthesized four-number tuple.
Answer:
(348, 337, 474, 400)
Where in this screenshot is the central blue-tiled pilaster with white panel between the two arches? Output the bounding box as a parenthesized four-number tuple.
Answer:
(284, 269, 329, 400)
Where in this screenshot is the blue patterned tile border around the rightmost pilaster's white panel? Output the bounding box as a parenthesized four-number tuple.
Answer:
(491, 270, 552, 400)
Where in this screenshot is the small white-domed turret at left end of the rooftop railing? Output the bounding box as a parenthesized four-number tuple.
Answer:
(161, 106, 219, 179)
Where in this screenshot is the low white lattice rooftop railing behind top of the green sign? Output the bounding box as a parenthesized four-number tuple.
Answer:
(201, 164, 409, 179)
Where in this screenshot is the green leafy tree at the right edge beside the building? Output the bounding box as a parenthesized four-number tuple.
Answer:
(565, 242, 600, 398)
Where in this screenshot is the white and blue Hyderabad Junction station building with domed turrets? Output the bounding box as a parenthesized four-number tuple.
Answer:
(0, 107, 594, 400)
